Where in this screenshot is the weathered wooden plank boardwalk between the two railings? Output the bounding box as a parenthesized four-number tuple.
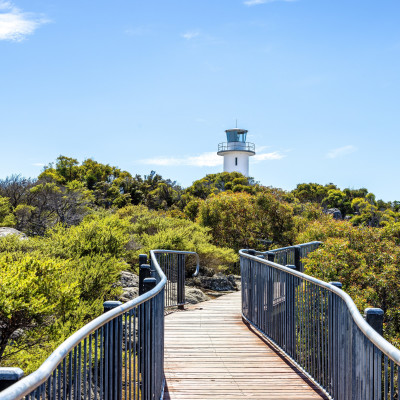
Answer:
(164, 292, 327, 400)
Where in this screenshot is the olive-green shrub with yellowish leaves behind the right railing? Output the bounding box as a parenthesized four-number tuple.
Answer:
(298, 220, 400, 346)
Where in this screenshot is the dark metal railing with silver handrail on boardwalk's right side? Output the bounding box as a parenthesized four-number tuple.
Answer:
(239, 250, 400, 400)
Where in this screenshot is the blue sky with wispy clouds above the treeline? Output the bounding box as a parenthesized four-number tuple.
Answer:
(0, 0, 400, 201)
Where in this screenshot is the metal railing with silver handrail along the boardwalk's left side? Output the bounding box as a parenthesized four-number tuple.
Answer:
(0, 250, 199, 400)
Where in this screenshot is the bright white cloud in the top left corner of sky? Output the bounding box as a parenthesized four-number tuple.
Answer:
(0, 0, 49, 42)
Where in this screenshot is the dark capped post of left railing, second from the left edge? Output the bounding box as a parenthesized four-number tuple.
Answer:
(103, 301, 122, 400)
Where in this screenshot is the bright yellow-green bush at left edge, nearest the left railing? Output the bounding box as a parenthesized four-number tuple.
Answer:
(0, 250, 78, 368)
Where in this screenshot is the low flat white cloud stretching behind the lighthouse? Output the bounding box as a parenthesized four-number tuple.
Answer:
(140, 151, 285, 167)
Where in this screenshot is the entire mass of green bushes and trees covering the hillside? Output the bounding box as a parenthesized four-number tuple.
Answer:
(0, 156, 400, 372)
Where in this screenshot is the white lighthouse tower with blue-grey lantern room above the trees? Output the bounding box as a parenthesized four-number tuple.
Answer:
(217, 128, 256, 176)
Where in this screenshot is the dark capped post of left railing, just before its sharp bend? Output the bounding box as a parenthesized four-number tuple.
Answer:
(139, 278, 157, 400)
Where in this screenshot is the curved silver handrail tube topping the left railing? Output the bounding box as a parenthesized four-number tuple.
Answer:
(0, 250, 177, 400)
